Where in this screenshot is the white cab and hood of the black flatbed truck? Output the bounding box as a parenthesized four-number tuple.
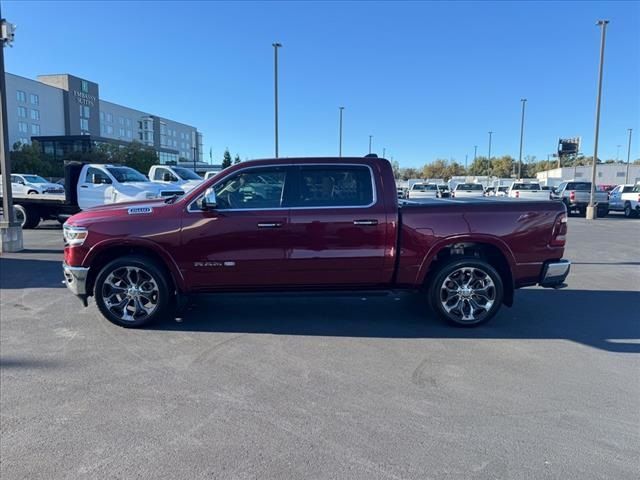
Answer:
(77, 164, 184, 210)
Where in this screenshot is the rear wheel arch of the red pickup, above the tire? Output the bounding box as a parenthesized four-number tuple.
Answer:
(418, 236, 515, 307)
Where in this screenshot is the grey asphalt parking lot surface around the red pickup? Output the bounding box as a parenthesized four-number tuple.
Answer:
(0, 215, 640, 480)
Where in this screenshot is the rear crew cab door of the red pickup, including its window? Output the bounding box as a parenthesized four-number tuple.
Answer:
(285, 163, 395, 287)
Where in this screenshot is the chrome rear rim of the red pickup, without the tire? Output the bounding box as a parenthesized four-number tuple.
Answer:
(440, 267, 496, 323)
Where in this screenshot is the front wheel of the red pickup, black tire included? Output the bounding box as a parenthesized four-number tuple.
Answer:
(93, 255, 171, 328)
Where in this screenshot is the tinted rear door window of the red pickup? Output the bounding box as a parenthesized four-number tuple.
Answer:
(292, 165, 373, 207)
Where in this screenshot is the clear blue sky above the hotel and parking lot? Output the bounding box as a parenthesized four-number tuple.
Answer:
(3, 1, 640, 166)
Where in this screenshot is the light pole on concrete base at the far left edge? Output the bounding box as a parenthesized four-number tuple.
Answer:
(0, 7, 23, 252)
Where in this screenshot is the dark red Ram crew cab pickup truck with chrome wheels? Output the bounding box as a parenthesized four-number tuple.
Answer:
(63, 156, 570, 327)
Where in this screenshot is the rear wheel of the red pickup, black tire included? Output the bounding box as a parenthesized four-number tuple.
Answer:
(428, 257, 504, 327)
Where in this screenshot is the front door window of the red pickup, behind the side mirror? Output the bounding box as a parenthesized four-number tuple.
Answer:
(214, 168, 285, 210)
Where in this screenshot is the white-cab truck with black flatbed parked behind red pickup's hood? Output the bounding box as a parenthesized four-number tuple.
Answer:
(0, 162, 184, 228)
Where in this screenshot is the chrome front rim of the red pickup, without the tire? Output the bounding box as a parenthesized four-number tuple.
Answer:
(102, 267, 160, 322)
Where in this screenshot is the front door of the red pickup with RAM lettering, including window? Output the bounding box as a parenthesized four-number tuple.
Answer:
(176, 166, 289, 291)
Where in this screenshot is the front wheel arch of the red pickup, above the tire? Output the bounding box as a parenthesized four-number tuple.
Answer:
(82, 240, 185, 295)
